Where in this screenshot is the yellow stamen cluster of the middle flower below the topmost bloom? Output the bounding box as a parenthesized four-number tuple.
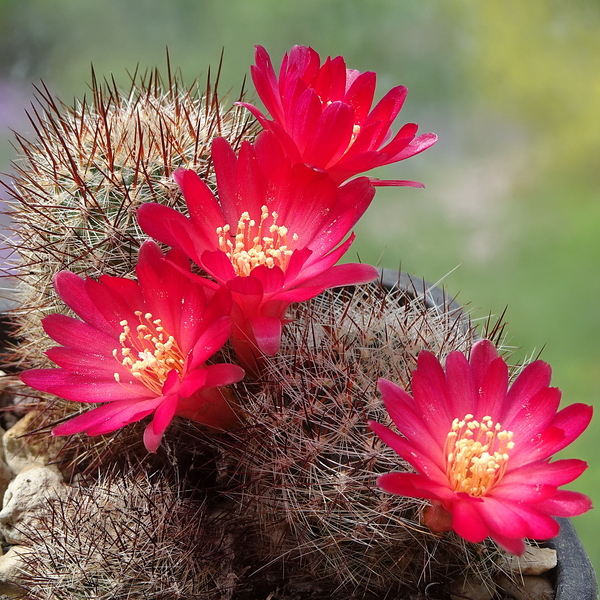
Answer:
(217, 206, 298, 277)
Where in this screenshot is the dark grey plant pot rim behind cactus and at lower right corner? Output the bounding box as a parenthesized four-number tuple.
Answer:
(381, 269, 598, 600)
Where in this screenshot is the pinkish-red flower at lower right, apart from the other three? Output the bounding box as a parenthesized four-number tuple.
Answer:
(370, 340, 592, 555)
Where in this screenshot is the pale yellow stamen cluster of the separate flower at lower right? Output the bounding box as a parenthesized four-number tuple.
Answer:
(444, 415, 515, 496)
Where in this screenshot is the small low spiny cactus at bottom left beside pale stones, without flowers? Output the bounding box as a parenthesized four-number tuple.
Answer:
(20, 465, 234, 600)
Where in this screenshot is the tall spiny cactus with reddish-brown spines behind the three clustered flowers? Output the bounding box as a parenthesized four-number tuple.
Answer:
(3, 67, 255, 368)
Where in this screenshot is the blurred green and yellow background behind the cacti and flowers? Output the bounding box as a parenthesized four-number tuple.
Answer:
(0, 0, 600, 570)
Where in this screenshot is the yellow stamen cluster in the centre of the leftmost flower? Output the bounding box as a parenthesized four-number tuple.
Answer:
(112, 310, 185, 396)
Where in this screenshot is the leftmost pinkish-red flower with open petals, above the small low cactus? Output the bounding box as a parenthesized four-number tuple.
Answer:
(21, 242, 244, 452)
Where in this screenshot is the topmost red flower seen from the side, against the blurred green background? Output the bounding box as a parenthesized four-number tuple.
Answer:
(241, 46, 437, 187)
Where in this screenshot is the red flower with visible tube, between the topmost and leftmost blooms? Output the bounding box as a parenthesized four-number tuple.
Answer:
(138, 132, 377, 369)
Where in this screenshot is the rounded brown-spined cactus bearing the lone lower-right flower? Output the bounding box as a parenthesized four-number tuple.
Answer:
(209, 284, 508, 597)
